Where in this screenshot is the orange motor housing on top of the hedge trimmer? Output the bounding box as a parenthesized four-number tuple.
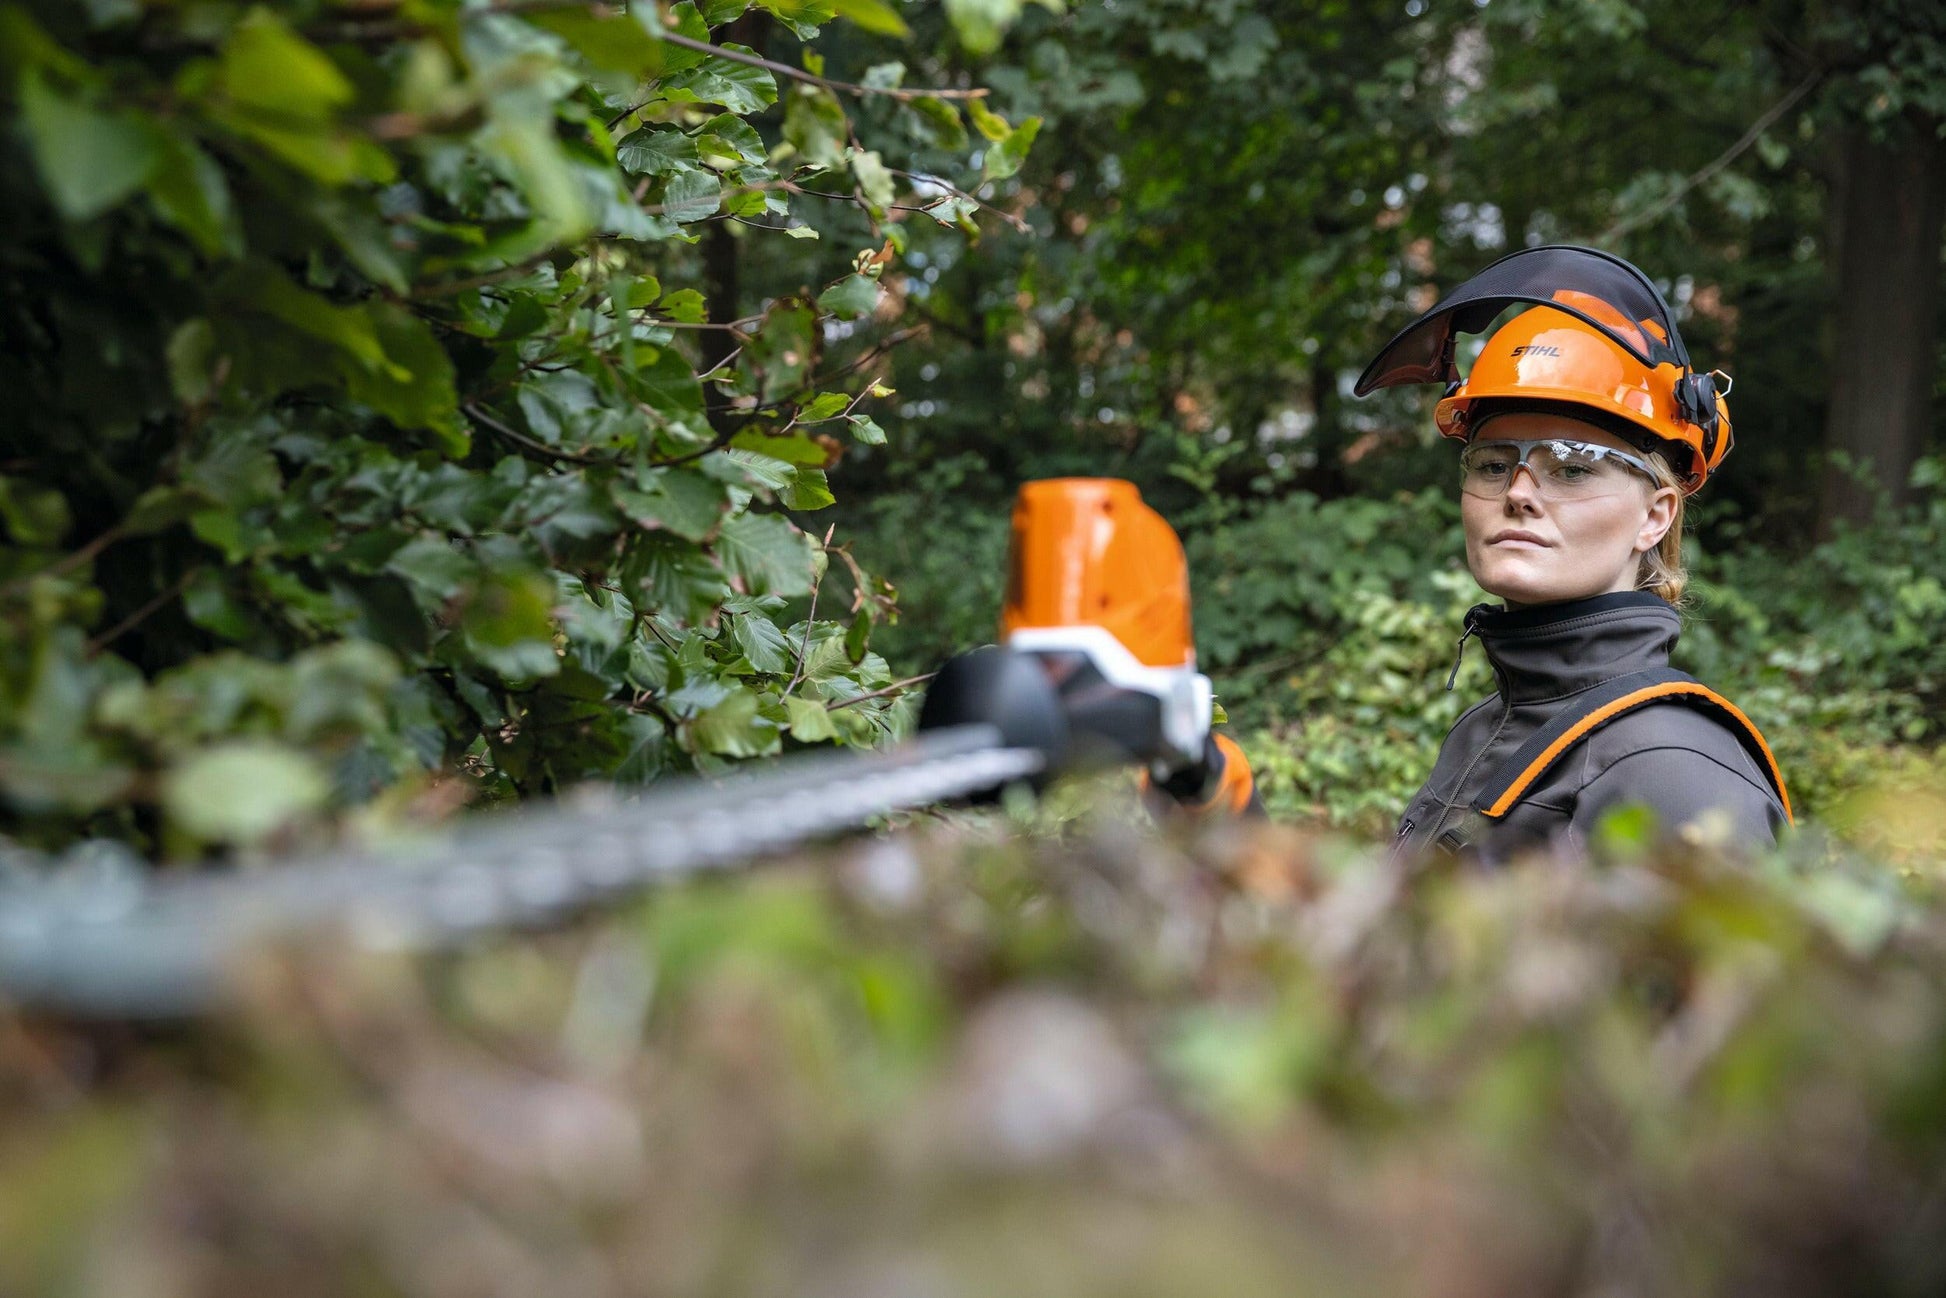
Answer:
(1000, 479, 1197, 667)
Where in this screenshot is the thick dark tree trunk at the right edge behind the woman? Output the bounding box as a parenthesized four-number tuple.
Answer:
(1818, 123, 1946, 535)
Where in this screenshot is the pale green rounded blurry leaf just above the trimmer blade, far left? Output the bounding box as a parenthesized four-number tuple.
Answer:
(162, 739, 331, 845)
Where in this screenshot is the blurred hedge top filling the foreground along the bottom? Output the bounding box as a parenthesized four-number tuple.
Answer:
(0, 800, 1946, 1298)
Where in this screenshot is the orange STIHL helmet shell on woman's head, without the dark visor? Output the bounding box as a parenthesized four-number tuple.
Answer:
(1432, 290, 1732, 492)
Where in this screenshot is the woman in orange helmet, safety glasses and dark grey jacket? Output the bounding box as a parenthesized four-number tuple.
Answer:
(1358, 247, 1790, 858)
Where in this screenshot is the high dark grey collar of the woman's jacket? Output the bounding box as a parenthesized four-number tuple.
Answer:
(1465, 590, 1683, 704)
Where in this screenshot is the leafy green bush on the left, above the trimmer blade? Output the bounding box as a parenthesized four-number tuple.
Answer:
(0, 0, 1033, 854)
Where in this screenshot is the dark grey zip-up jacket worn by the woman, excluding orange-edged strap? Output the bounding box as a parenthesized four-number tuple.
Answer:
(1395, 592, 1784, 860)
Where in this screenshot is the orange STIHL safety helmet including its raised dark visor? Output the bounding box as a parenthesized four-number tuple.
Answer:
(1352, 243, 1730, 492)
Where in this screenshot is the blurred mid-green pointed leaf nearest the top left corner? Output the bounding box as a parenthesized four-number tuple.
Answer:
(19, 68, 162, 220)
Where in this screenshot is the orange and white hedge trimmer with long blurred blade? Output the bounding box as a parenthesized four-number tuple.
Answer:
(0, 479, 1247, 1016)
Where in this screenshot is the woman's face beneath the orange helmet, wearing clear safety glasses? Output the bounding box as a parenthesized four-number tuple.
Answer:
(1460, 413, 1677, 607)
